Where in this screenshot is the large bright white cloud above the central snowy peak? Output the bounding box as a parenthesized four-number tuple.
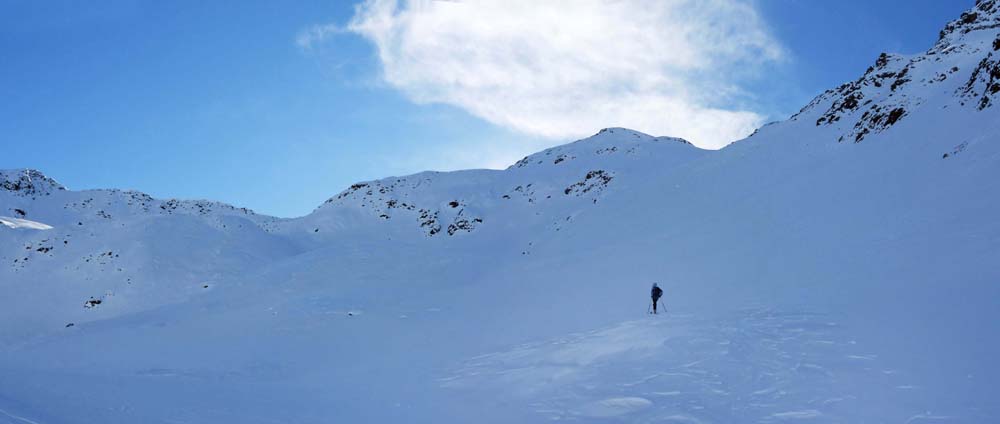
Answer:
(314, 0, 783, 148)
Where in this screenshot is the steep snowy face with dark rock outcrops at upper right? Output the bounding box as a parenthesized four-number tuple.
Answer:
(791, 0, 1000, 143)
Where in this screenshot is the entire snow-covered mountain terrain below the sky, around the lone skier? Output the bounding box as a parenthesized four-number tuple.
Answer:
(0, 0, 1000, 423)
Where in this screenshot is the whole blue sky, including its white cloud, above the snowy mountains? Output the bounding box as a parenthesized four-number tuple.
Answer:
(0, 0, 973, 216)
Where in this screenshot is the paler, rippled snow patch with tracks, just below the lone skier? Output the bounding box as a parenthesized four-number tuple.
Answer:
(441, 309, 956, 423)
